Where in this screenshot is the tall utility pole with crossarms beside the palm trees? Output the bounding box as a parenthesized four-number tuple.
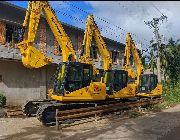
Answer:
(145, 14, 167, 83)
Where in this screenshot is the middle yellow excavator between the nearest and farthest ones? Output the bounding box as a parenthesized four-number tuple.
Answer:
(80, 15, 136, 99)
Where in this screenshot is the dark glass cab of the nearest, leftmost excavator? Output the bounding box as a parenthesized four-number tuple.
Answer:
(54, 62, 93, 96)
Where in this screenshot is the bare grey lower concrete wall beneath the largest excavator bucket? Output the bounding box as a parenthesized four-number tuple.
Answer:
(0, 60, 55, 105)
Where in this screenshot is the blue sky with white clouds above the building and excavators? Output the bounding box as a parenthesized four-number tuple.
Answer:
(9, 1, 180, 53)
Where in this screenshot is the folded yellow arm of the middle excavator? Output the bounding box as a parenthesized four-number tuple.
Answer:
(80, 15, 112, 71)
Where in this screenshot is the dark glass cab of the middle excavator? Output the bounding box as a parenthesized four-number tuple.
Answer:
(103, 70, 128, 95)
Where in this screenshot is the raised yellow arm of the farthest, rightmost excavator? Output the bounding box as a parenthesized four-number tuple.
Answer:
(124, 32, 144, 85)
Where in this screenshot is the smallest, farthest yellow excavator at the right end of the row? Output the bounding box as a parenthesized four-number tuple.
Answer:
(124, 33, 162, 98)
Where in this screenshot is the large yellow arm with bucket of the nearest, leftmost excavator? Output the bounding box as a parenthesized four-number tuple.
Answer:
(18, 1, 76, 68)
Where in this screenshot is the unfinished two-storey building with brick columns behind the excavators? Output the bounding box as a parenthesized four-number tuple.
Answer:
(0, 1, 125, 105)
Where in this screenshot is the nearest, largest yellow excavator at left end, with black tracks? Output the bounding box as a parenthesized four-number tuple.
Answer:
(18, 1, 106, 124)
